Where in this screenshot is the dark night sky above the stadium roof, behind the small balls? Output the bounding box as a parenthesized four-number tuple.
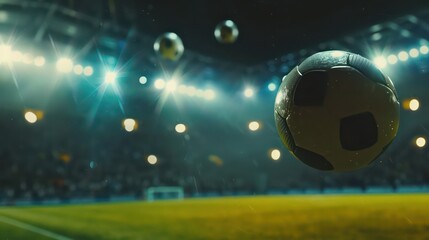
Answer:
(125, 0, 429, 64)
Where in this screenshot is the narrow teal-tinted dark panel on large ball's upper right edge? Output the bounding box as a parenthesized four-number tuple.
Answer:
(348, 54, 384, 86)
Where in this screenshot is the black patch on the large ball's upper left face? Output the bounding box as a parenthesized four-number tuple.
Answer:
(294, 71, 329, 106)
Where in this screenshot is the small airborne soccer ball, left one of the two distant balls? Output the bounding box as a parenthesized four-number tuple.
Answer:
(153, 32, 185, 61)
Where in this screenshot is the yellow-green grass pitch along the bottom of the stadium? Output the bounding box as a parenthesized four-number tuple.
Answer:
(0, 194, 429, 240)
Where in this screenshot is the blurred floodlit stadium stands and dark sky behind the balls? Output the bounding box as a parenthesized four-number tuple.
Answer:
(0, 0, 429, 208)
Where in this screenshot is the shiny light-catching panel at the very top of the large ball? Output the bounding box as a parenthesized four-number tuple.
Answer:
(298, 51, 349, 74)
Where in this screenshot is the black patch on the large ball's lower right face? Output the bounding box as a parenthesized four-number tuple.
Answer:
(340, 112, 378, 151)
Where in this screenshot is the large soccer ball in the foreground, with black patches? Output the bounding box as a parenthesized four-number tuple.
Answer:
(274, 51, 399, 171)
